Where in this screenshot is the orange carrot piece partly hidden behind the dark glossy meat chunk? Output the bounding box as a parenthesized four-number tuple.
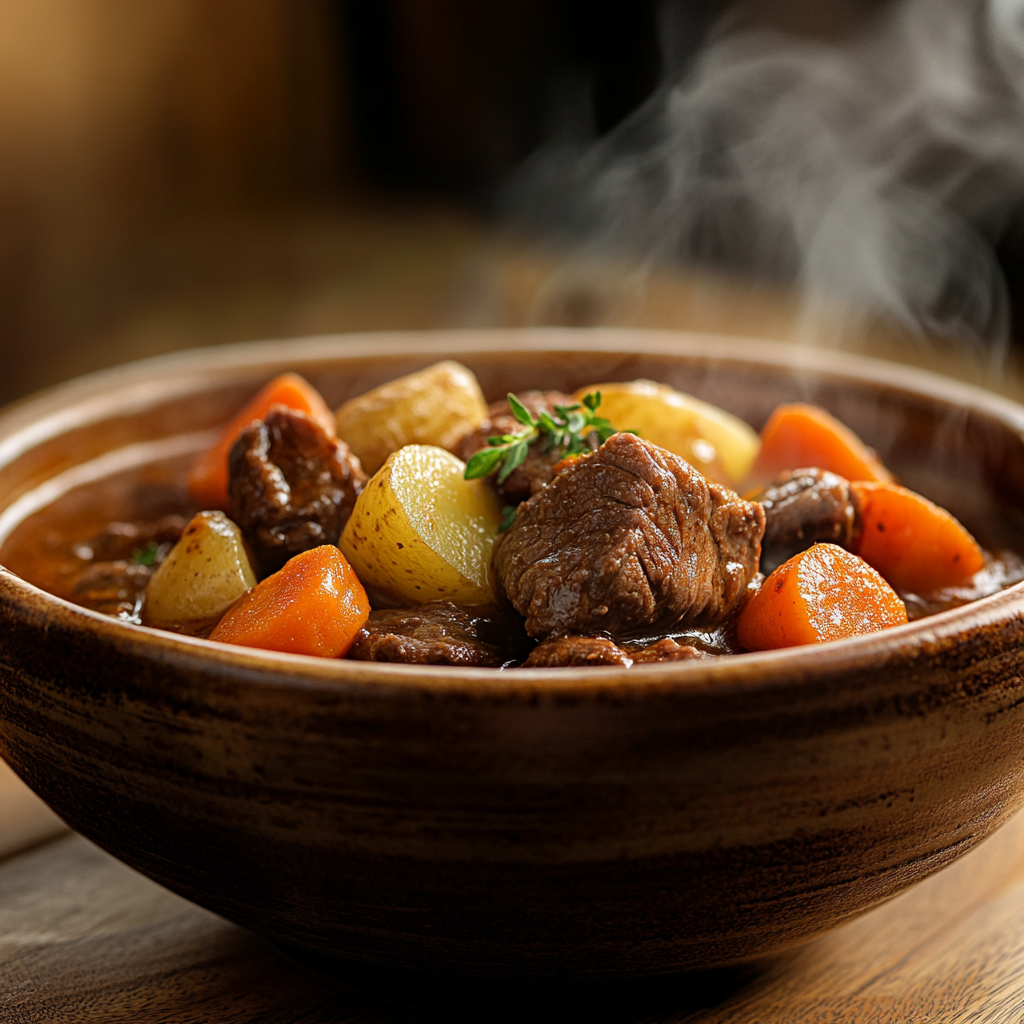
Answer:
(188, 374, 335, 512)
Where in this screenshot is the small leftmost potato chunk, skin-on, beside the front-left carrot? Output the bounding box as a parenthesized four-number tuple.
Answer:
(141, 512, 256, 632)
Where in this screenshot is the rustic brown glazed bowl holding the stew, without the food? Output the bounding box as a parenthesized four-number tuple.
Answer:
(0, 331, 1024, 979)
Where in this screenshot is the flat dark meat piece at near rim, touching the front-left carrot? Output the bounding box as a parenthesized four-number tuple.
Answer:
(348, 601, 529, 668)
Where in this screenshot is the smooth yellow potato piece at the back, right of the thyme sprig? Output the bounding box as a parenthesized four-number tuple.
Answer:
(575, 380, 761, 487)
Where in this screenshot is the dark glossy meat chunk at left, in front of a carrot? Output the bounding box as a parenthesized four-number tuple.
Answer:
(227, 406, 367, 579)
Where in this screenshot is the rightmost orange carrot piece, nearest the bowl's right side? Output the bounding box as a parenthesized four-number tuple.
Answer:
(853, 483, 985, 596)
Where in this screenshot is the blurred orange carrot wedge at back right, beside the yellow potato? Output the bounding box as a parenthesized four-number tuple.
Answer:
(752, 402, 892, 483)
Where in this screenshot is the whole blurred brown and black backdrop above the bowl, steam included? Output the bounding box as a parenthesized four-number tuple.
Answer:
(0, 0, 1024, 401)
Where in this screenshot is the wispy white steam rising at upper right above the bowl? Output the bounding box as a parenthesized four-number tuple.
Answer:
(508, 0, 1024, 360)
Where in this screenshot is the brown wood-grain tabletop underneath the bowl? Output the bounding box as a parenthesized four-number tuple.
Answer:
(0, 763, 1024, 1024)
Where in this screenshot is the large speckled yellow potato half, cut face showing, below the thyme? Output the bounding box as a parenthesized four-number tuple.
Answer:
(339, 444, 501, 604)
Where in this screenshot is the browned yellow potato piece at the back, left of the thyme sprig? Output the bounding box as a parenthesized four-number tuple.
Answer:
(337, 359, 487, 474)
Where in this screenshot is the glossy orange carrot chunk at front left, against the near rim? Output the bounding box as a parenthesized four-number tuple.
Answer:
(210, 544, 370, 657)
